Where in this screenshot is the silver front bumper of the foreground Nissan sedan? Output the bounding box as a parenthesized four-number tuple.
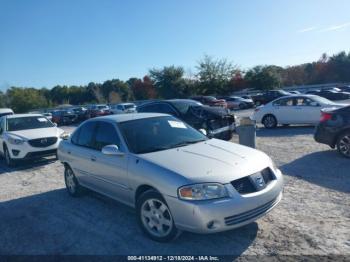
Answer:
(165, 171, 283, 233)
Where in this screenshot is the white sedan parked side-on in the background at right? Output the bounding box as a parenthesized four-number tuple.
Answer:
(252, 95, 345, 128)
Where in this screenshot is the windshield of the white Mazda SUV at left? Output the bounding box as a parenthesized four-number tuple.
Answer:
(6, 116, 54, 131)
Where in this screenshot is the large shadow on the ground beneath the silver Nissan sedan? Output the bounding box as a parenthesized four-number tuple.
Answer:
(0, 189, 258, 257)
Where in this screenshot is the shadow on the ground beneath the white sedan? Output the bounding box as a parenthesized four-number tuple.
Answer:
(256, 125, 315, 137)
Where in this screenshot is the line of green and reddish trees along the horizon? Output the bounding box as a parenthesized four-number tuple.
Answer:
(0, 51, 350, 113)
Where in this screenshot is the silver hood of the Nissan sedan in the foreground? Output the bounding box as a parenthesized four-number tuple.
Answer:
(140, 139, 272, 184)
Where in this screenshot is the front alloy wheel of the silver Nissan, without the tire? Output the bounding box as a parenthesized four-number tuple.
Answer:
(141, 198, 173, 237)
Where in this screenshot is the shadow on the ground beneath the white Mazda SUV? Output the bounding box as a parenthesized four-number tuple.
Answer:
(0, 157, 57, 174)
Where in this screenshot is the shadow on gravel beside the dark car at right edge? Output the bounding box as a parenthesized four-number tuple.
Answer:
(281, 150, 350, 193)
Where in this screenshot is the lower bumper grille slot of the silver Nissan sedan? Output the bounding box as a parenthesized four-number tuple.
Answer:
(225, 197, 279, 226)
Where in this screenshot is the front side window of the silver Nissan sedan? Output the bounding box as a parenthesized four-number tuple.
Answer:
(94, 122, 120, 151)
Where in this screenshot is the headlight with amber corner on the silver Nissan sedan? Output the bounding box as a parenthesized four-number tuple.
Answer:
(178, 183, 228, 200)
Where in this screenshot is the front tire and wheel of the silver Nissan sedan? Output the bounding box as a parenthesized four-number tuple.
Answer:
(136, 190, 180, 242)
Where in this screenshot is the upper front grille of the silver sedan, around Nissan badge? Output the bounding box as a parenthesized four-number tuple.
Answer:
(231, 167, 276, 195)
